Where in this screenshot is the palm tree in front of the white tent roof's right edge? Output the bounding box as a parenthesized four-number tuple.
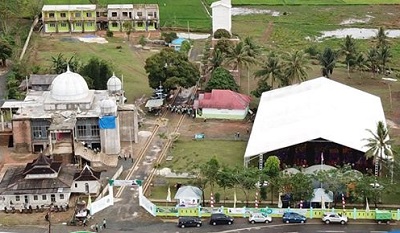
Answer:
(365, 121, 393, 177)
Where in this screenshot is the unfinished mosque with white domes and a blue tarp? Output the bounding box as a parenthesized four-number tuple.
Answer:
(1, 68, 138, 166)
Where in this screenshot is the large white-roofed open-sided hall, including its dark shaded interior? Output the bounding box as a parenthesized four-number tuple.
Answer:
(244, 77, 386, 171)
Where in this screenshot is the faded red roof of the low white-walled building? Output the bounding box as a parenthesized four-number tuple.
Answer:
(198, 89, 251, 109)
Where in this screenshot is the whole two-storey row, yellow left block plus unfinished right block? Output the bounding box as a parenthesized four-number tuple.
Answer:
(42, 4, 159, 33)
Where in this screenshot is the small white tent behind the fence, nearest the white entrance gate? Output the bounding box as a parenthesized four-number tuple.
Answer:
(174, 185, 203, 207)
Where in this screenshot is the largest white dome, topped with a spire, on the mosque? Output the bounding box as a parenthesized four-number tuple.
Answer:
(50, 67, 89, 101)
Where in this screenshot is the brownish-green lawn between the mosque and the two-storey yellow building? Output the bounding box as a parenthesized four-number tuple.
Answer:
(27, 34, 152, 103)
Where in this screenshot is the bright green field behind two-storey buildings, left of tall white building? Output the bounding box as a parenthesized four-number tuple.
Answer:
(44, 0, 211, 32)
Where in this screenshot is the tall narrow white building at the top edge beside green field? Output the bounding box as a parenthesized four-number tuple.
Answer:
(211, 0, 232, 34)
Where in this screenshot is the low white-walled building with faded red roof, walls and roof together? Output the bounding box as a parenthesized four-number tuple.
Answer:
(194, 89, 251, 120)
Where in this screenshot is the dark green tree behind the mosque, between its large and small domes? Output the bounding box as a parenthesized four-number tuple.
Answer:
(80, 57, 112, 90)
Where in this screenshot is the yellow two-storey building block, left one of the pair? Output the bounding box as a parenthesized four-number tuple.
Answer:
(42, 5, 97, 33)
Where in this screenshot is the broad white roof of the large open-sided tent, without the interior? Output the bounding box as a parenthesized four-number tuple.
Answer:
(244, 77, 386, 158)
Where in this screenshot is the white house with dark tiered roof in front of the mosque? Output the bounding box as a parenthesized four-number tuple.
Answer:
(0, 154, 76, 210)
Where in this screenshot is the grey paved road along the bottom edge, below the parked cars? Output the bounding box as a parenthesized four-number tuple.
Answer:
(0, 218, 400, 233)
